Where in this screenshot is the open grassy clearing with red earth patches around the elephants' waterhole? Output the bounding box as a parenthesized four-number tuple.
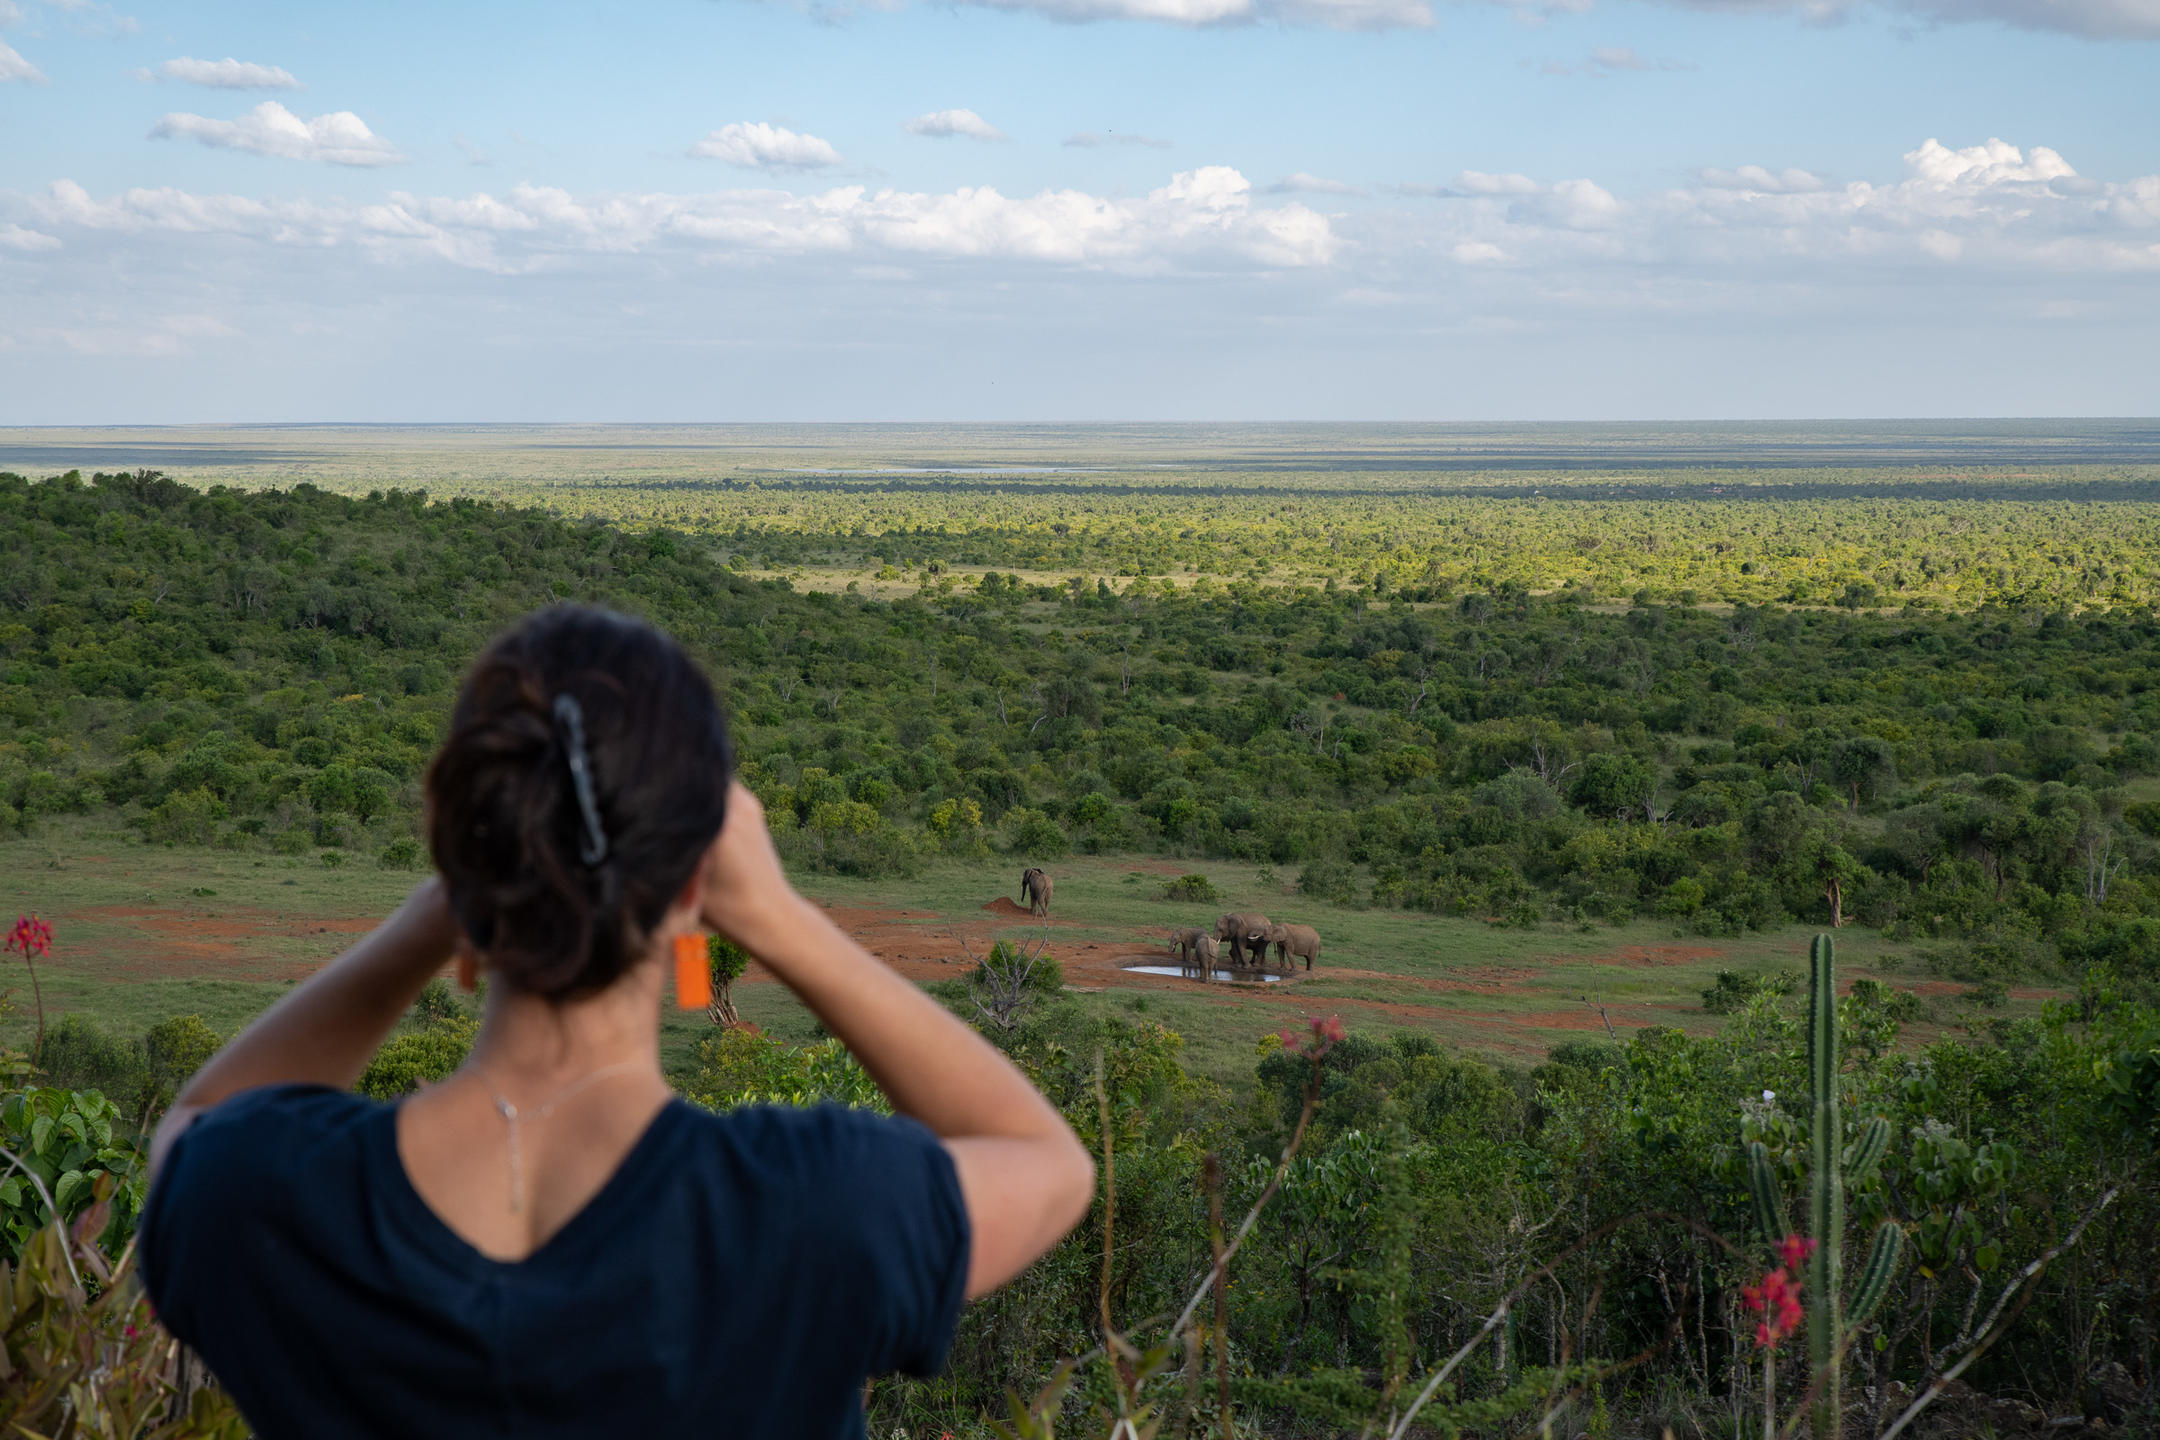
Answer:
(0, 820, 2054, 1082)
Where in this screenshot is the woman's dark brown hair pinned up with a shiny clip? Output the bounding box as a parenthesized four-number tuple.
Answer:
(428, 604, 730, 1000)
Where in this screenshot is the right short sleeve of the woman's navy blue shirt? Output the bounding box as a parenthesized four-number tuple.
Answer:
(773, 1105, 972, 1380)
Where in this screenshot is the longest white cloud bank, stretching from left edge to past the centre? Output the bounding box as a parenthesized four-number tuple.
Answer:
(35, 166, 1341, 272)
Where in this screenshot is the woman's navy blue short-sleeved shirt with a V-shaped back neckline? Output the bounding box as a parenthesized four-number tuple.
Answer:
(140, 1086, 968, 1440)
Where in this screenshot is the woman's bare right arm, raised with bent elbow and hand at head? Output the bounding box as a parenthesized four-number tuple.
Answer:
(700, 784, 1095, 1298)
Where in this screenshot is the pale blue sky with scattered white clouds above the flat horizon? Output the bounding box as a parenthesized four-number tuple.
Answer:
(0, 0, 2160, 423)
